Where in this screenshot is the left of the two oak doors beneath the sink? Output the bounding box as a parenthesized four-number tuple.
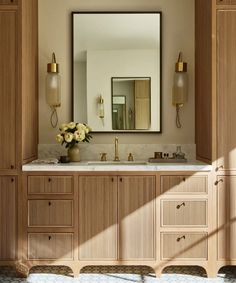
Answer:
(79, 176, 117, 260)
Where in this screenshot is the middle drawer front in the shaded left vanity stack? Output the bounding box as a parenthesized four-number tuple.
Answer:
(28, 200, 73, 227)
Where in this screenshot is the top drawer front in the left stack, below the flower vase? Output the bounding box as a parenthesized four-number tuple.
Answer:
(28, 176, 73, 194)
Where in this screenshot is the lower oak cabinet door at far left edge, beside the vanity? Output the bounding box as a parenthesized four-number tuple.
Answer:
(0, 176, 16, 260)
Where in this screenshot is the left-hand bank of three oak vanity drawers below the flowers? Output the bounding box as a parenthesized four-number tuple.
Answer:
(21, 175, 75, 266)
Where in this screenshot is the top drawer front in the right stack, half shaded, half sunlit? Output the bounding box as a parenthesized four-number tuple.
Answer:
(161, 175, 207, 194)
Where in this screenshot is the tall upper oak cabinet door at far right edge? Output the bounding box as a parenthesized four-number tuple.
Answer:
(217, 10, 236, 170)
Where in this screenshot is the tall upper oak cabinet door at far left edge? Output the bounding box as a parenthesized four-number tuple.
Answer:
(0, 10, 17, 169)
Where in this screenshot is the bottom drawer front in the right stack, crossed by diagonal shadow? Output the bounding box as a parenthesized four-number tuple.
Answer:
(161, 233, 208, 260)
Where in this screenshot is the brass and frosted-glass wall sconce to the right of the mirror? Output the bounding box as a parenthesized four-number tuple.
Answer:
(172, 52, 188, 128)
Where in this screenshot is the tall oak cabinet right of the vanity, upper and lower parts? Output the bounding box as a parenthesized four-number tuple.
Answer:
(195, 0, 236, 272)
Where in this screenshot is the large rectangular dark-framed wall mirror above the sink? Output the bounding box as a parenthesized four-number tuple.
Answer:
(72, 12, 161, 132)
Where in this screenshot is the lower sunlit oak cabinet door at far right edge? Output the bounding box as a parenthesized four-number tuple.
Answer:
(217, 176, 236, 260)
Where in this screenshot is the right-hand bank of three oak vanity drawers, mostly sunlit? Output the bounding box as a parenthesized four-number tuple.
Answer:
(160, 173, 209, 275)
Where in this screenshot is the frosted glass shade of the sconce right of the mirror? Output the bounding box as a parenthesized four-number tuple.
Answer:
(172, 72, 188, 106)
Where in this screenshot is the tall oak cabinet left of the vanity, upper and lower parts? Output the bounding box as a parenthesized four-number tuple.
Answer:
(0, 0, 38, 265)
